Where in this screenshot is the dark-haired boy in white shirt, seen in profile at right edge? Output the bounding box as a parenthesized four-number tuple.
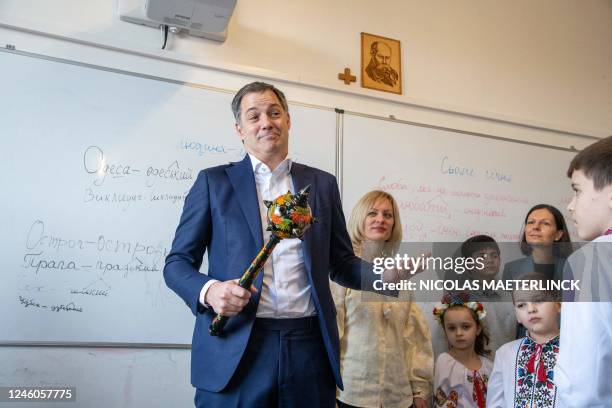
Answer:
(554, 136, 612, 408)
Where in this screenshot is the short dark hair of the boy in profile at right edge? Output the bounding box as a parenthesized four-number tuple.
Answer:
(567, 136, 612, 190)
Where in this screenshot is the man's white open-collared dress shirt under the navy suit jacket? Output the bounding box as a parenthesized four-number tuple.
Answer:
(200, 154, 315, 319)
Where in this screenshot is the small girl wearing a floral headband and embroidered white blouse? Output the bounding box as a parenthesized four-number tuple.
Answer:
(433, 293, 493, 408)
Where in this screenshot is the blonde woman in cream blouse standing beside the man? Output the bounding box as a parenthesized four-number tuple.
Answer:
(332, 191, 433, 408)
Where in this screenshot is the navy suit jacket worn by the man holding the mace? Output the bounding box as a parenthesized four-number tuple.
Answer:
(164, 155, 373, 392)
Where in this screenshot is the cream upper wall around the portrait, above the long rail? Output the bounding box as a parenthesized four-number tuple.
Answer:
(0, 0, 612, 137)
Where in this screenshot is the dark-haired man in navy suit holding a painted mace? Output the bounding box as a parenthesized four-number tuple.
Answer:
(164, 82, 374, 408)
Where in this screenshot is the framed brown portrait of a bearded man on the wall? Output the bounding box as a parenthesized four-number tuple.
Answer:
(361, 33, 402, 94)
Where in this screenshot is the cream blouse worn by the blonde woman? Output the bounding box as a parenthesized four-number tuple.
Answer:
(331, 282, 434, 408)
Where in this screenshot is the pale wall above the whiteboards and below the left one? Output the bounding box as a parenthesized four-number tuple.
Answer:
(0, 0, 612, 407)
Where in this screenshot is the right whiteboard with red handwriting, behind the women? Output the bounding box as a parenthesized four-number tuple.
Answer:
(342, 114, 576, 244)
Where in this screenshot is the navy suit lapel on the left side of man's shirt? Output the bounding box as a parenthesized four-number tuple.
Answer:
(225, 154, 263, 248)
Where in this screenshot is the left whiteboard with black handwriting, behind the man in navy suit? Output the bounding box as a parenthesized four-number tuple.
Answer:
(0, 52, 336, 344)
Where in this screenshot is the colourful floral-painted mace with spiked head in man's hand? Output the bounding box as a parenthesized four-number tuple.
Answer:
(208, 185, 316, 336)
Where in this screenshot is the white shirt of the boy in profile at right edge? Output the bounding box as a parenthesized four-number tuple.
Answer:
(554, 235, 612, 408)
